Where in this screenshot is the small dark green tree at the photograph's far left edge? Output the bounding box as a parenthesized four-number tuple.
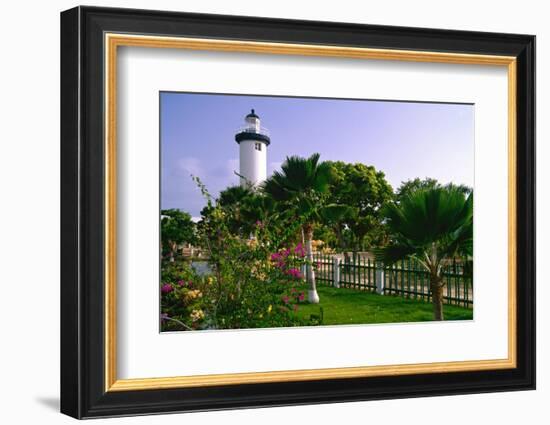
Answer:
(160, 209, 196, 261)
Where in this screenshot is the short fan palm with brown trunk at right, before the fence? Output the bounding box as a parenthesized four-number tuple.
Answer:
(375, 186, 473, 320)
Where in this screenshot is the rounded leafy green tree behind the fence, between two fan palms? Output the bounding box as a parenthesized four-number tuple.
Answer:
(328, 161, 393, 255)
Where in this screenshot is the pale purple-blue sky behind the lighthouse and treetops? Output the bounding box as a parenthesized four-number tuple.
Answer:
(160, 92, 474, 217)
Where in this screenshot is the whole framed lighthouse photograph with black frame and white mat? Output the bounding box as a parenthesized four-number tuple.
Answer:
(61, 7, 535, 418)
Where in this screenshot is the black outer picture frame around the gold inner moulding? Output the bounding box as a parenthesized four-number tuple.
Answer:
(61, 7, 535, 418)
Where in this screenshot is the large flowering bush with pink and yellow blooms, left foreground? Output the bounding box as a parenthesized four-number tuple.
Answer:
(161, 174, 322, 330)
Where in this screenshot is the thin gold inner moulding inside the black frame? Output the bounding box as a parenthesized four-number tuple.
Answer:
(104, 33, 517, 391)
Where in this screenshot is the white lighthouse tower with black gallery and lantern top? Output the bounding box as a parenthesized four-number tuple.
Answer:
(235, 109, 271, 187)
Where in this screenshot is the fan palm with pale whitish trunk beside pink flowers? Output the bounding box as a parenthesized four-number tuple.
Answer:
(263, 153, 331, 304)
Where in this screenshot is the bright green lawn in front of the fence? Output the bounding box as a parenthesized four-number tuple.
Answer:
(298, 286, 473, 325)
